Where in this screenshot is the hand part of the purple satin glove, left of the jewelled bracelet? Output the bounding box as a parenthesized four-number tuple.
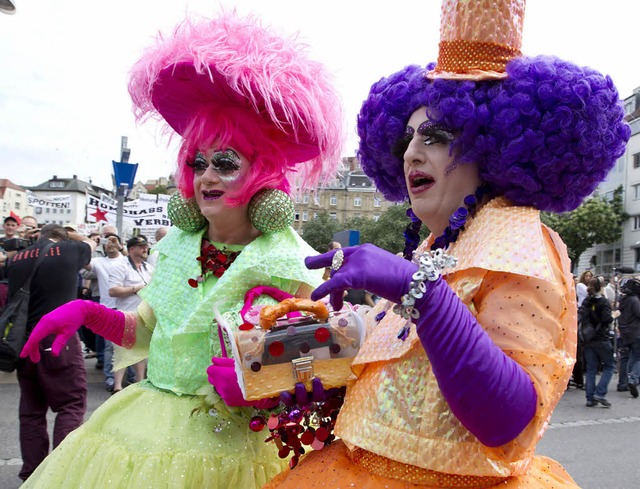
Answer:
(304, 244, 418, 311)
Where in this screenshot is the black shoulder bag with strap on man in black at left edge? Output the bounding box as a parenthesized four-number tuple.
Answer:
(0, 243, 53, 372)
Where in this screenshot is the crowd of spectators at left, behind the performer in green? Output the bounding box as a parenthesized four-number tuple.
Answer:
(0, 215, 167, 480)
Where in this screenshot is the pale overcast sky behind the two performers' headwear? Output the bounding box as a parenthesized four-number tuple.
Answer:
(0, 0, 640, 188)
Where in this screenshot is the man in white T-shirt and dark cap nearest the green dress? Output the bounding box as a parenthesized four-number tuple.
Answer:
(109, 236, 154, 393)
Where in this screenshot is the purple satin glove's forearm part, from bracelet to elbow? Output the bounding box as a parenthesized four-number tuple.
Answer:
(416, 278, 537, 447)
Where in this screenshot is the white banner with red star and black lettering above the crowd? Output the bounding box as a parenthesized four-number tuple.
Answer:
(87, 194, 171, 243)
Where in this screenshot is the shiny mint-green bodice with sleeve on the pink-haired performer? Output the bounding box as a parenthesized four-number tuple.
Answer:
(140, 228, 322, 395)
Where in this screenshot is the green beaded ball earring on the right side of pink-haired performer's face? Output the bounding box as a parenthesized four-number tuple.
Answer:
(248, 188, 295, 234)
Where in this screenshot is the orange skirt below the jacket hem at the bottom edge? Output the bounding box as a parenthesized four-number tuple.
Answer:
(263, 441, 578, 489)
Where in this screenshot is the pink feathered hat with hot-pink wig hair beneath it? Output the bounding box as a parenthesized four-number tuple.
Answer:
(129, 12, 344, 205)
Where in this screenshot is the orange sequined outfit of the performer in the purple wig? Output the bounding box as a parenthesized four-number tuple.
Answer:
(265, 198, 577, 489)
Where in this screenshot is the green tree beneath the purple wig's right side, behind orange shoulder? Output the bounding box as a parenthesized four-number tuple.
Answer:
(540, 186, 629, 265)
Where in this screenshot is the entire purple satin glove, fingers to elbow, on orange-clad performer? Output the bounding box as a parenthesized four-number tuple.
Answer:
(305, 244, 537, 446)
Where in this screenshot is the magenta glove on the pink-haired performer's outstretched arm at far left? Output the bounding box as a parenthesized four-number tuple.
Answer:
(20, 299, 127, 362)
